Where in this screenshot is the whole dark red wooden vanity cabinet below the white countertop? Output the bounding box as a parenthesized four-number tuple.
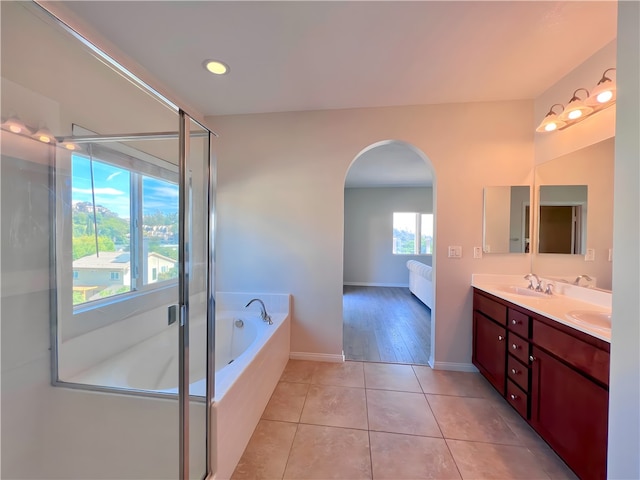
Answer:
(472, 290, 609, 479)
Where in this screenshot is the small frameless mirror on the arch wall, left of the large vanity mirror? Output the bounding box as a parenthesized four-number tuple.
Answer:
(482, 185, 531, 253)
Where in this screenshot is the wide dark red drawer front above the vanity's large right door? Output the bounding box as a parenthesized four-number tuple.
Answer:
(532, 320, 609, 386)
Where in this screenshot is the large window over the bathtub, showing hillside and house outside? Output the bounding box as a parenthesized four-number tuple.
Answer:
(71, 152, 178, 306)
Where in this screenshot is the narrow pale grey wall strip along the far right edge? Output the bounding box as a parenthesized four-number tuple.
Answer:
(608, 2, 640, 479)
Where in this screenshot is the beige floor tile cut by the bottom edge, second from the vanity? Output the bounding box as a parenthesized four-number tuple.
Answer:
(447, 440, 549, 480)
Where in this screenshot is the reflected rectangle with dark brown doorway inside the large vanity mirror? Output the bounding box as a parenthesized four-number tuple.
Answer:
(538, 185, 588, 255)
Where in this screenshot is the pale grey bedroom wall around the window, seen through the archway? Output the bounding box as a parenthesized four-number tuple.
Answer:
(344, 187, 433, 286)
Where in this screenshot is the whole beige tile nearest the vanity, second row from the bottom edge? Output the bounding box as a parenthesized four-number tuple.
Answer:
(426, 395, 522, 445)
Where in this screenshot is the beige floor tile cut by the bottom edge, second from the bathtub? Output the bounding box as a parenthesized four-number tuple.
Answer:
(284, 425, 371, 480)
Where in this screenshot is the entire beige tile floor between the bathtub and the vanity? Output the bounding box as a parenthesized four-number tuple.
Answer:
(232, 360, 576, 480)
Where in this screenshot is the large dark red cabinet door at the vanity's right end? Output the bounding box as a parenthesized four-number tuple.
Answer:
(530, 346, 609, 479)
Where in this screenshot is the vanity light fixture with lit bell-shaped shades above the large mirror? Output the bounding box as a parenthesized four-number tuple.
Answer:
(536, 68, 616, 132)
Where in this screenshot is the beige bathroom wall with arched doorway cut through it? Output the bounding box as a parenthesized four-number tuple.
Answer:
(207, 101, 533, 368)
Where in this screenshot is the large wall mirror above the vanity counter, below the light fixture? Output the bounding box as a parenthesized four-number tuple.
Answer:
(531, 138, 614, 290)
